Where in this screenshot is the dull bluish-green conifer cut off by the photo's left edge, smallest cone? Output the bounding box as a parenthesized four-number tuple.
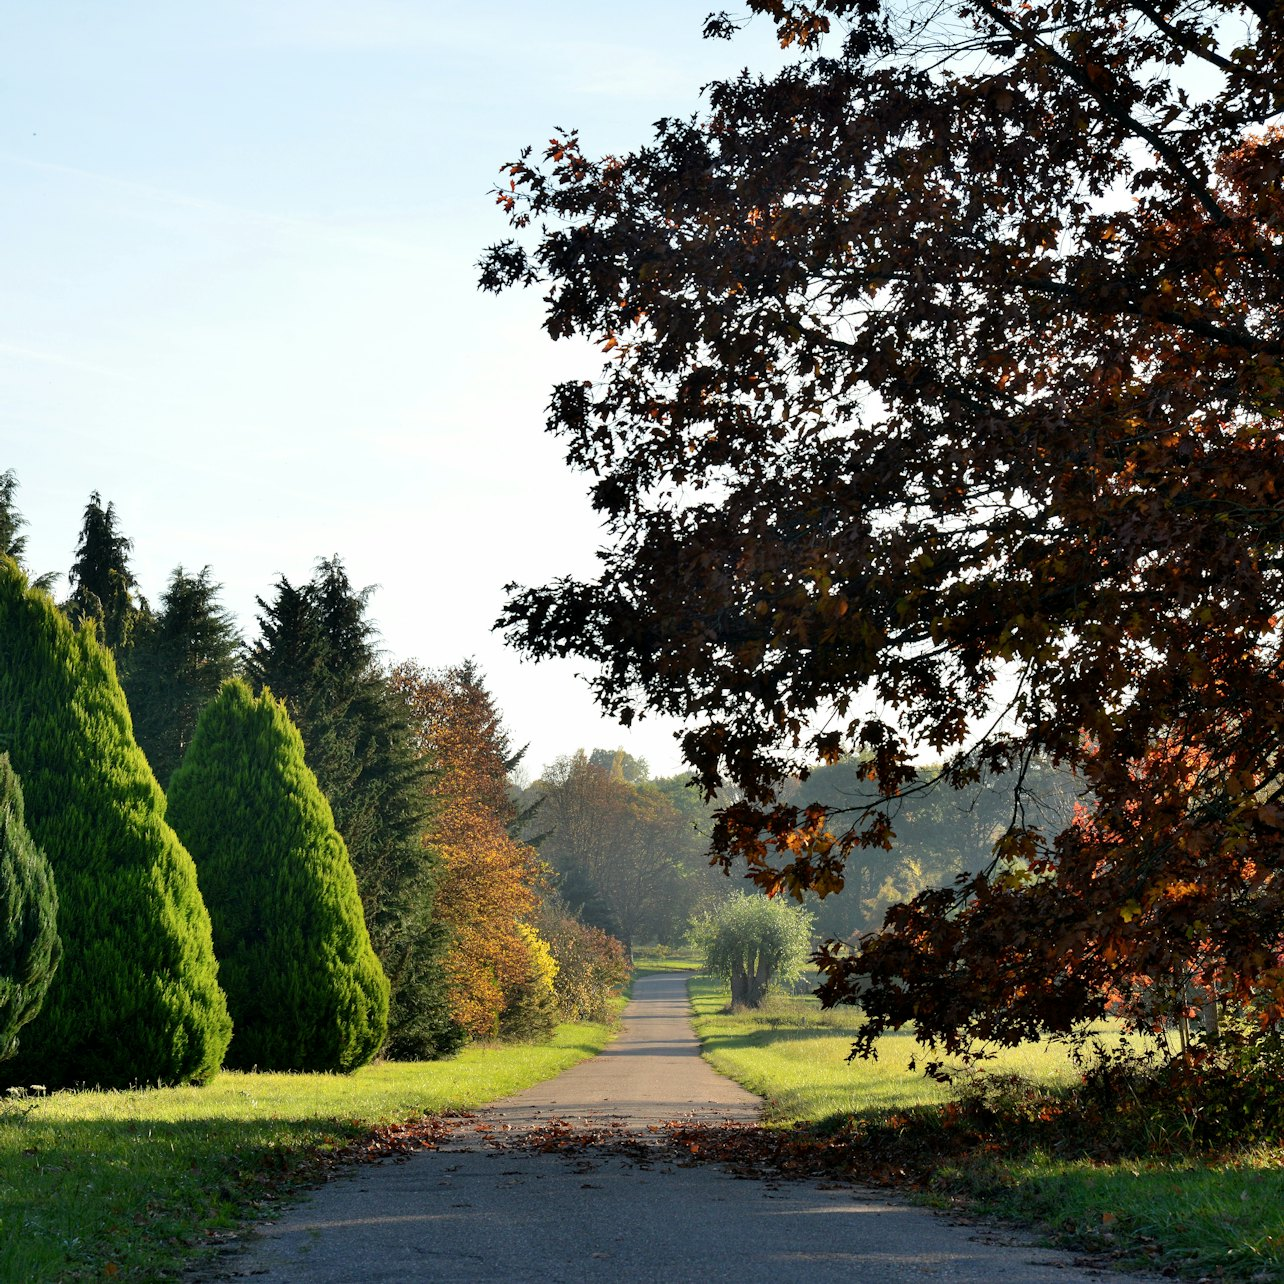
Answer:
(0, 754, 63, 1061)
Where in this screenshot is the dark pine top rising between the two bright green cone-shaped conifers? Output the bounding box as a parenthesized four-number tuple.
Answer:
(121, 566, 240, 785)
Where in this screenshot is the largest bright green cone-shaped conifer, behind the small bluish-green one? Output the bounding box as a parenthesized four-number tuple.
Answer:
(0, 557, 231, 1088)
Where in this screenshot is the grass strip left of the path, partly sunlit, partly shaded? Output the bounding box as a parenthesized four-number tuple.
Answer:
(0, 1025, 610, 1281)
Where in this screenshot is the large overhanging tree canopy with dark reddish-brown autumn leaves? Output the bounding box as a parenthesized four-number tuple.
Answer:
(483, 0, 1284, 1048)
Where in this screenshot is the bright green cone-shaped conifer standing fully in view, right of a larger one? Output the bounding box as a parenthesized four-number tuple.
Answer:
(169, 678, 388, 1071)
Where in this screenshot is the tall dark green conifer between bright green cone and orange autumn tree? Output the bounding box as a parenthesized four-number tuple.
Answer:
(245, 557, 460, 1059)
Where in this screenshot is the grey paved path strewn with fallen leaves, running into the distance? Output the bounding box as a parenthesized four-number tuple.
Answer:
(215, 976, 1136, 1284)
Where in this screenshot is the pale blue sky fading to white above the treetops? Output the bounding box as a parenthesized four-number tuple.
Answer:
(0, 0, 783, 774)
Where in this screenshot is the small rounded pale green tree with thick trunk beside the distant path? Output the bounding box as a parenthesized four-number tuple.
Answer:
(691, 892, 811, 1008)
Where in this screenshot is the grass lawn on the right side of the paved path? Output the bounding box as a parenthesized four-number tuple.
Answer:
(691, 977, 1284, 1280)
